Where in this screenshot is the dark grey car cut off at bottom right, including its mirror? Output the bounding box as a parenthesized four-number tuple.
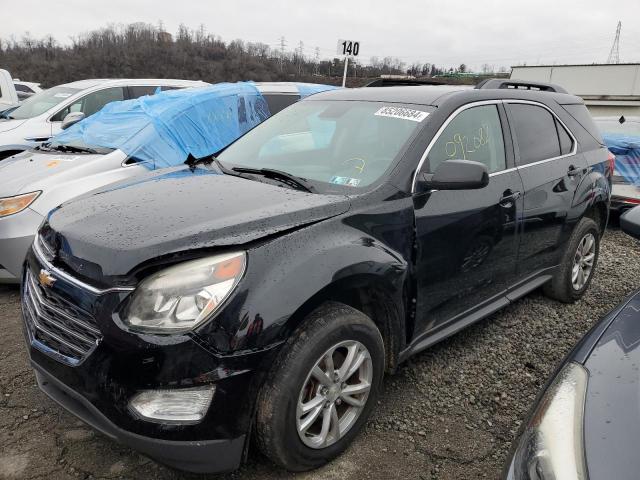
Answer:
(505, 207, 640, 480)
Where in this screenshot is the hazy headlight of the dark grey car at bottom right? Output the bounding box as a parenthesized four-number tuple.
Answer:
(509, 363, 588, 480)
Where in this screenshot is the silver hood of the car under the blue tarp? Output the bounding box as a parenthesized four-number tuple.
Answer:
(0, 150, 147, 215)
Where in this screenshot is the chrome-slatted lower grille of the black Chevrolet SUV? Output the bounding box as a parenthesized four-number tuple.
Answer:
(22, 269, 102, 365)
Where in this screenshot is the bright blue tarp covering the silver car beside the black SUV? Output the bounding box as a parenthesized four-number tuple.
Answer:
(51, 82, 335, 169)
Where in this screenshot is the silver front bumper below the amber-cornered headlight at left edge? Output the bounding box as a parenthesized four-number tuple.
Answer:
(0, 208, 42, 283)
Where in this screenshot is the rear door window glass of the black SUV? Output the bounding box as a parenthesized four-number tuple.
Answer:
(509, 103, 566, 166)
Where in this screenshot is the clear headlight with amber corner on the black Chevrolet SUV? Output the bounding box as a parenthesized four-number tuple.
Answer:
(123, 252, 246, 333)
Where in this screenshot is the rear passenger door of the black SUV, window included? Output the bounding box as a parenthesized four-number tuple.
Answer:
(506, 100, 587, 279)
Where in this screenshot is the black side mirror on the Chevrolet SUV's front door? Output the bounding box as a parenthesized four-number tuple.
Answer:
(419, 160, 489, 191)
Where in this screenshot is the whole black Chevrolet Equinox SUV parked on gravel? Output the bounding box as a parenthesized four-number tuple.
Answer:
(22, 80, 613, 472)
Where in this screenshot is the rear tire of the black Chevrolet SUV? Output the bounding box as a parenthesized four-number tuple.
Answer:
(544, 217, 600, 303)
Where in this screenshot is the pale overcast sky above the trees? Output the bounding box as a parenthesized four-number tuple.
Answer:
(0, 0, 640, 70)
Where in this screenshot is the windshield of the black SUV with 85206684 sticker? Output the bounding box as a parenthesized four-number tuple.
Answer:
(219, 100, 433, 193)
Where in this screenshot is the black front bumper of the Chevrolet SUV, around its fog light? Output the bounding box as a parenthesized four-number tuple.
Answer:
(22, 250, 277, 473)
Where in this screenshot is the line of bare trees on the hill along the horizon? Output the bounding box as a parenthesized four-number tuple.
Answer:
(0, 23, 476, 87)
